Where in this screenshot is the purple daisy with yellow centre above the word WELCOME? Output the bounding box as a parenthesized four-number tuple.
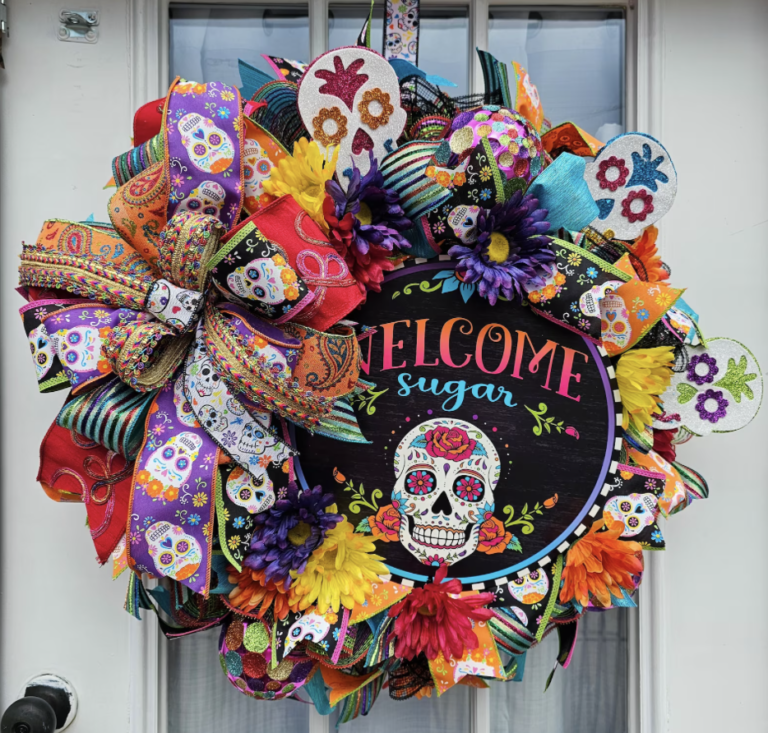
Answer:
(448, 191, 555, 305)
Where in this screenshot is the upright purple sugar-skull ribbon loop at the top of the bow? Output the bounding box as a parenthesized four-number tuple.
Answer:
(165, 81, 243, 229)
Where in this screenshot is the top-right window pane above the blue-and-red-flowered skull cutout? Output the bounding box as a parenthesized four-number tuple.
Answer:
(488, 6, 625, 142)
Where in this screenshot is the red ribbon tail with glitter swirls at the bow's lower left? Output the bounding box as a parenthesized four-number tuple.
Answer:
(37, 422, 133, 565)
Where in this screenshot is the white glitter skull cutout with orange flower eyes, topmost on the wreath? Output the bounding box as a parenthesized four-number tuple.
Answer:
(298, 46, 407, 189)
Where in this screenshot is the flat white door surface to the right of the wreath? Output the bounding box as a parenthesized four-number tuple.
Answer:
(661, 0, 768, 733)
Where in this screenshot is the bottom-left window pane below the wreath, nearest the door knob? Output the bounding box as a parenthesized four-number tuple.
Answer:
(167, 629, 309, 733)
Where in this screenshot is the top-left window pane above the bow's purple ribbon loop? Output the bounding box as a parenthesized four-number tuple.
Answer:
(170, 4, 308, 87)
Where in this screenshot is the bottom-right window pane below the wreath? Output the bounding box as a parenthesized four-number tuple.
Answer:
(491, 609, 637, 733)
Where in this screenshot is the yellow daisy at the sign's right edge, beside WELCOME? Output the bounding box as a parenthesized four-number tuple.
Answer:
(616, 346, 675, 432)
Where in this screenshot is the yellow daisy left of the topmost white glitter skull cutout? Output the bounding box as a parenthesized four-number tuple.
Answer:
(264, 138, 339, 232)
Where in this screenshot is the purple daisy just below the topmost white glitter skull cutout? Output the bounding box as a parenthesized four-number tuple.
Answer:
(325, 153, 413, 255)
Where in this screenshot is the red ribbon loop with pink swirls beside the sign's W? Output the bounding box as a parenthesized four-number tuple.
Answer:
(238, 196, 365, 331)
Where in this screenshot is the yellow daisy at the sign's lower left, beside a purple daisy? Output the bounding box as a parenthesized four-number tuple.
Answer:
(290, 519, 389, 615)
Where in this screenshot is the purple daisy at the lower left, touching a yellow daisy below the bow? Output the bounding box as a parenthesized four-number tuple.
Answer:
(243, 481, 341, 587)
